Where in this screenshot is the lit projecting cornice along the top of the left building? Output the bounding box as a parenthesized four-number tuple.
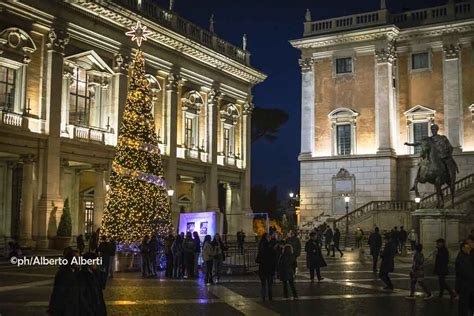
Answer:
(71, 1, 267, 84)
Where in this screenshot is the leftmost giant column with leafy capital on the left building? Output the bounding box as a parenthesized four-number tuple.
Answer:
(37, 28, 69, 248)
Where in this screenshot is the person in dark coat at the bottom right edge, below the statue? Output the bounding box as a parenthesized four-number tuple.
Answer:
(455, 240, 474, 316)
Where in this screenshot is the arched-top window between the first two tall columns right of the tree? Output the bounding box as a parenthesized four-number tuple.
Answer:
(181, 90, 204, 149)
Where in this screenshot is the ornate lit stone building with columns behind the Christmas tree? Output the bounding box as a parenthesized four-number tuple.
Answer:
(0, 0, 265, 247)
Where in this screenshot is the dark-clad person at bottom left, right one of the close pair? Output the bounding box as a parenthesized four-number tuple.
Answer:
(78, 253, 107, 316)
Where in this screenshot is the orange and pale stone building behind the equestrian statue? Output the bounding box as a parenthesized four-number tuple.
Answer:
(291, 0, 474, 226)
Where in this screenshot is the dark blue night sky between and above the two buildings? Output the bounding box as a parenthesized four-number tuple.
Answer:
(157, 0, 446, 197)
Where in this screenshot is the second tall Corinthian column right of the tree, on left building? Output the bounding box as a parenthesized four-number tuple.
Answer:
(206, 89, 221, 212)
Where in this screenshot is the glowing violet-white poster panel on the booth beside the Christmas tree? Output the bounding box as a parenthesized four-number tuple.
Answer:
(179, 212, 219, 238)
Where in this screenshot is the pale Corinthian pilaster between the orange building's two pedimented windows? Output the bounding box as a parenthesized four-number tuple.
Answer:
(375, 43, 396, 154)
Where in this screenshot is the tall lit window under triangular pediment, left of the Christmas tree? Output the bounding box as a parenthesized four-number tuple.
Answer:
(69, 67, 91, 125)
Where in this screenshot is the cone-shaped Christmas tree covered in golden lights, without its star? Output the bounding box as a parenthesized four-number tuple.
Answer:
(100, 50, 172, 243)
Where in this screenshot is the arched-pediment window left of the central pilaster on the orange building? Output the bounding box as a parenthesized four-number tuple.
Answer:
(328, 108, 359, 156)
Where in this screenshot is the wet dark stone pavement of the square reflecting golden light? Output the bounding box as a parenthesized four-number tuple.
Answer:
(0, 253, 457, 316)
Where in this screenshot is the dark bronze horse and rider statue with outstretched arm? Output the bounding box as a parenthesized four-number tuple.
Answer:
(405, 124, 459, 208)
